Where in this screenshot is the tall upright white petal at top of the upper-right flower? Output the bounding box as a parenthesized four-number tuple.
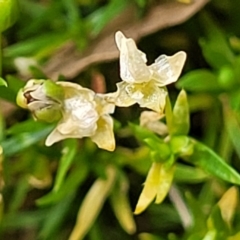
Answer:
(115, 31, 151, 83)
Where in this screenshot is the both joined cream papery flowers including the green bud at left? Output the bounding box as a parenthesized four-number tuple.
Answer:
(17, 32, 186, 151)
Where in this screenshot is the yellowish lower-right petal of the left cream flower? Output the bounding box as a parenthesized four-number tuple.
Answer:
(91, 115, 115, 151)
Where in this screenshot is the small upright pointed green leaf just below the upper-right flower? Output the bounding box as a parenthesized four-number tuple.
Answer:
(171, 90, 190, 135)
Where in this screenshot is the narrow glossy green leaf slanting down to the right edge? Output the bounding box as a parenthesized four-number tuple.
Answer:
(183, 139, 240, 185)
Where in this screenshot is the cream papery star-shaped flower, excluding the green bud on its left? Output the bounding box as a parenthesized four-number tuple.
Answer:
(46, 82, 115, 151)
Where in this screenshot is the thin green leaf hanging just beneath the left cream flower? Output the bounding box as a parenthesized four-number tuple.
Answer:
(53, 139, 77, 192)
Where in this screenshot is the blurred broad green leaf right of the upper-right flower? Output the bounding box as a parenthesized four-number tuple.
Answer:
(176, 69, 221, 92)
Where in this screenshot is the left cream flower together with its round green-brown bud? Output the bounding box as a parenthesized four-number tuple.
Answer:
(17, 79, 115, 151)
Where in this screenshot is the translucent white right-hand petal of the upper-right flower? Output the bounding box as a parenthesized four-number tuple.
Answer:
(149, 51, 186, 87)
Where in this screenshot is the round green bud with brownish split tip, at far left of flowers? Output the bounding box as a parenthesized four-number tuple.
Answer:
(17, 79, 64, 122)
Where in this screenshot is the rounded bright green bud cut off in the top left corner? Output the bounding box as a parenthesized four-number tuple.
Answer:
(0, 0, 19, 32)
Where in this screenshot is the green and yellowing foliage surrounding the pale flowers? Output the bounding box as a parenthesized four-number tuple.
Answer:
(0, 0, 240, 240)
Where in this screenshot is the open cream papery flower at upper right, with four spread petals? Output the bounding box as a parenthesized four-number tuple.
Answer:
(109, 32, 186, 112)
